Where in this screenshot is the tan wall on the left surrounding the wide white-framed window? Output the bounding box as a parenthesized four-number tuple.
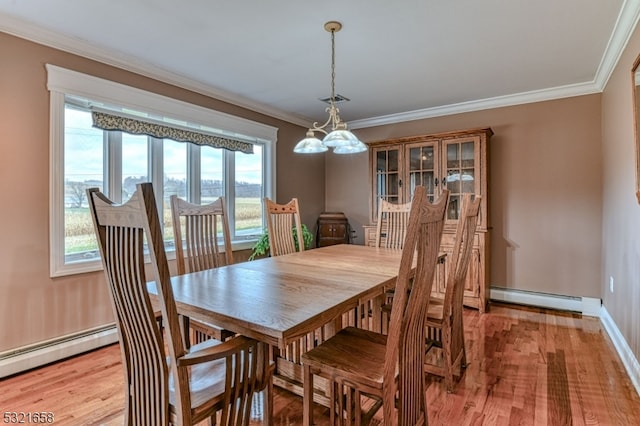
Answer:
(0, 33, 324, 352)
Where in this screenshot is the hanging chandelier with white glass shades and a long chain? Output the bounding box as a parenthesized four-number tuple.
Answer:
(293, 21, 367, 154)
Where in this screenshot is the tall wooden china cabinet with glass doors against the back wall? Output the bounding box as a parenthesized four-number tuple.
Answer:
(364, 128, 493, 312)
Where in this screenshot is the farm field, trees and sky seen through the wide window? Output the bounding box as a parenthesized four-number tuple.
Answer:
(64, 105, 263, 262)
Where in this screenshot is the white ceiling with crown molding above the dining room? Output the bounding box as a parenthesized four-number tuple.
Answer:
(0, 0, 640, 128)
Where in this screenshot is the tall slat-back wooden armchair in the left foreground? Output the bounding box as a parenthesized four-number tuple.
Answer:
(87, 183, 273, 426)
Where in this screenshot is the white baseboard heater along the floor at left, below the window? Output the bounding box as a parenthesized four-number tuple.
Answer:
(0, 324, 118, 378)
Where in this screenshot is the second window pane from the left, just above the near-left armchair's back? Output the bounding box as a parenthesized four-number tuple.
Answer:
(122, 133, 149, 203)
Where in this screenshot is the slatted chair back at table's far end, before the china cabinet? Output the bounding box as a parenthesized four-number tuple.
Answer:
(376, 198, 411, 249)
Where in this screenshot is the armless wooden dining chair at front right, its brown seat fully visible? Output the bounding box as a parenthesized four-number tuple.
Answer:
(302, 186, 448, 426)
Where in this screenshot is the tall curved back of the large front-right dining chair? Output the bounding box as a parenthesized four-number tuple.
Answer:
(383, 186, 449, 425)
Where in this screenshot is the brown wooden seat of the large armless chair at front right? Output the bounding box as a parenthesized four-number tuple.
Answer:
(301, 327, 387, 390)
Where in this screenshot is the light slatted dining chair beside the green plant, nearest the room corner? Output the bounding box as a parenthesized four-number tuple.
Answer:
(264, 198, 304, 257)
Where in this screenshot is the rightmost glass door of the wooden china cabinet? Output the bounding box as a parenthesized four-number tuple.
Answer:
(442, 138, 480, 220)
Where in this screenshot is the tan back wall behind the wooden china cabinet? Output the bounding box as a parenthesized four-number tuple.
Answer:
(326, 95, 602, 298)
